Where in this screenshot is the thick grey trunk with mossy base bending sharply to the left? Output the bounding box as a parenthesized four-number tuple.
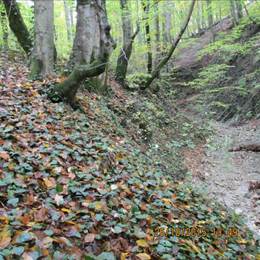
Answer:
(49, 0, 115, 106)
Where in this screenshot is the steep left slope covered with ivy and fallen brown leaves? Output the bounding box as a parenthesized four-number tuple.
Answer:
(0, 52, 258, 259)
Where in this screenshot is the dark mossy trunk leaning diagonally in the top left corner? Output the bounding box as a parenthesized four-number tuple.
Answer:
(3, 0, 33, 56)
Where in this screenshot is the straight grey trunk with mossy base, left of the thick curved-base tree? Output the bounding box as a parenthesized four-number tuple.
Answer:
(31, 0, 55, 77)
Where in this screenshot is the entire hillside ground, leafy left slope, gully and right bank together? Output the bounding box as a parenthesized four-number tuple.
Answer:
(0, 1, 260, 260)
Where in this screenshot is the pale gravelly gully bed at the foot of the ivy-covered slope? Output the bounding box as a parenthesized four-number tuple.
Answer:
(186, 121, 260, 237)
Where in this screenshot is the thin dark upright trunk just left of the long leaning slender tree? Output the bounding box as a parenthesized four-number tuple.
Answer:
(142, 0, 153, 73)
